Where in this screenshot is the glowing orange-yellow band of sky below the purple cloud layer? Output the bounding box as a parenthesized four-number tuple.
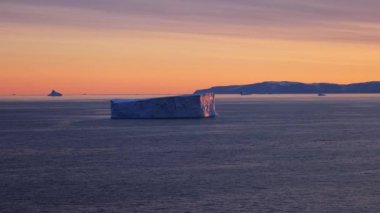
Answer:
(0, 1, 380, 95)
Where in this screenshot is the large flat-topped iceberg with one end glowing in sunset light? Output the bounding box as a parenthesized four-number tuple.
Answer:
(111, 93, 216, 119)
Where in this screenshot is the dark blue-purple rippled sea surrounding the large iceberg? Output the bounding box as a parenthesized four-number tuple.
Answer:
(0, 95, 380, 212)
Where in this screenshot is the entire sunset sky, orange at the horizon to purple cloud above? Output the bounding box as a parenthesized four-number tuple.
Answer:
(0, 0, 380, 95)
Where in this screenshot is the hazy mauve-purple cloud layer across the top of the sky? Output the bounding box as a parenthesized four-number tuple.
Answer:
(0, 0, 380, 43)
